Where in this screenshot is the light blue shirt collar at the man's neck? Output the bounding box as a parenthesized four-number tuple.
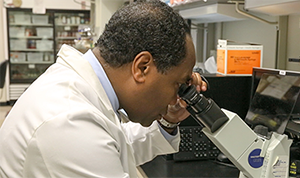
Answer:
(83, 50, 119, 112)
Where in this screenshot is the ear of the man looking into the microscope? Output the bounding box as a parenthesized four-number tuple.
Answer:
(131, 51, 153, 83)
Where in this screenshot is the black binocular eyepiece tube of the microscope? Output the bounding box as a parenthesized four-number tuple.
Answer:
(178, 84, 229, 133)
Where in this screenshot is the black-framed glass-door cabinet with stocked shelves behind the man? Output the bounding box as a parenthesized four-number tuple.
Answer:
(7, 8, 90, 100)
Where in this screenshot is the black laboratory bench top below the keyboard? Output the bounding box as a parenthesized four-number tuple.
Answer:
(141, 156, 240, 178)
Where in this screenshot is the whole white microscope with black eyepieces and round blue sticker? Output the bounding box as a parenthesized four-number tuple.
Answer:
(178, 84, 292, 178)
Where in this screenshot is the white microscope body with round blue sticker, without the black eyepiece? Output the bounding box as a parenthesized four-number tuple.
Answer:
(203, 109, 292, 178)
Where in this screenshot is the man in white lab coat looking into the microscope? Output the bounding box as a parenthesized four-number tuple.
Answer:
(0, 0, 206, 178)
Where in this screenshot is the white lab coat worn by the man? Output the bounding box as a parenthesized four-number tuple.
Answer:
(0, 45, 179, 178)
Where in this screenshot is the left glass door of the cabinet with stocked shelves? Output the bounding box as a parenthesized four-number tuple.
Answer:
(7, 9, 54, 83)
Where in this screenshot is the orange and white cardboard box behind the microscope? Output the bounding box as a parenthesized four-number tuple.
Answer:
(217, 40, 263, 75)
